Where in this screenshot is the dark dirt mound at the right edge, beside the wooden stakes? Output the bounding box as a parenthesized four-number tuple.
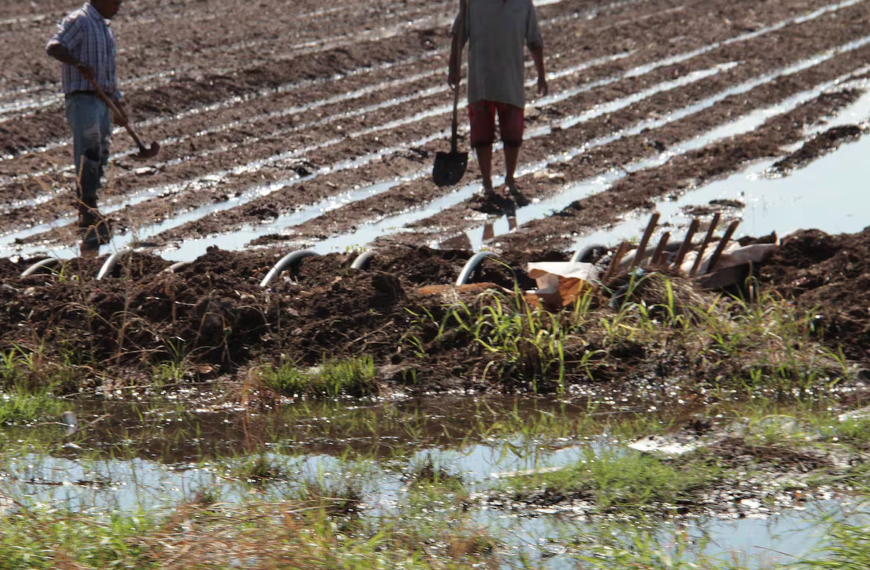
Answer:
(759, 228, 870, 362)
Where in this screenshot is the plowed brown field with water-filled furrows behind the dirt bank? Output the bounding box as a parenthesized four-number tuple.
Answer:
(0, 0, 870, 260)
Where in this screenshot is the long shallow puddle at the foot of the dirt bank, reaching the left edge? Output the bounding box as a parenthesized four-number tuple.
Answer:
(0, 397, 632, 509)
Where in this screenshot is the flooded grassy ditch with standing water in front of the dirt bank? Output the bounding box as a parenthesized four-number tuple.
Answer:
(0, 396, 857, 568)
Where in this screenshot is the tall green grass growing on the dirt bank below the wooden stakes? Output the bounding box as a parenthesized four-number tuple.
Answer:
(405, 274, 849, 398)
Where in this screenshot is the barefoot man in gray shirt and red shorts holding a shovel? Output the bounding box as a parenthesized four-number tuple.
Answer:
(447, 0, 549, 198)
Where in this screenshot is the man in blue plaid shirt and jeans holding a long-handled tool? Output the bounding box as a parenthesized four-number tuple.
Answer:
(46, 0, 127, 239)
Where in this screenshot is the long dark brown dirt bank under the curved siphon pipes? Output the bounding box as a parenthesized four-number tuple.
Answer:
(0, 244, 558, 370)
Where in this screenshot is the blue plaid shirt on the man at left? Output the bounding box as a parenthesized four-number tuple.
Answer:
(51, 2, 122, 99)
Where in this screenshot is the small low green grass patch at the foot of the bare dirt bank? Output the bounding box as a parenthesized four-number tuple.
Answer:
(262, 356, 377, 398)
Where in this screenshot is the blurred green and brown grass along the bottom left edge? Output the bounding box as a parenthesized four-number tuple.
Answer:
(0, 501, 498, 570)
